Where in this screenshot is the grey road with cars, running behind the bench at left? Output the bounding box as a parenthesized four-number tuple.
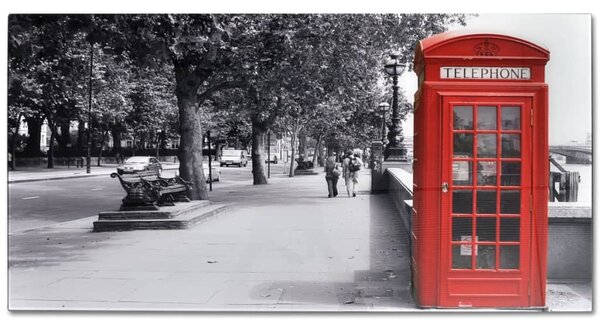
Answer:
(8, 164, 292, 233)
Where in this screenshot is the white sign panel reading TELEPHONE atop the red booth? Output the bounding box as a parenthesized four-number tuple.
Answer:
(440, 66, 531, 80)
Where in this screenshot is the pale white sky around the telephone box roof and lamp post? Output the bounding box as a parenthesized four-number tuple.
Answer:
(401, 14, 592, 145)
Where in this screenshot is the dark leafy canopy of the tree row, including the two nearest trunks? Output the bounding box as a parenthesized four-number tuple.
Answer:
(8, 14, 465, 195)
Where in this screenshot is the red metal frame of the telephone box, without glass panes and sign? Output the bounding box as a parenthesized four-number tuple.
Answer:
(411, 33, 549, 307)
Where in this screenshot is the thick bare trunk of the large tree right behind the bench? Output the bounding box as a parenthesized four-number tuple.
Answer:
(176, 86, 208, 200)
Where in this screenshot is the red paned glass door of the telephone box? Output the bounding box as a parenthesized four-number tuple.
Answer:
(439, 96, 535, 307)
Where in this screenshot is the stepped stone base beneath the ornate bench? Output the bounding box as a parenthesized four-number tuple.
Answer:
(94, 200, 226, 232)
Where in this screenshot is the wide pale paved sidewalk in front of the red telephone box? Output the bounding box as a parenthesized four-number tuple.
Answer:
(8, 168, 591, 312)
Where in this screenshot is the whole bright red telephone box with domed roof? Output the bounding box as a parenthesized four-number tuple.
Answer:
(411, 32, 549, 308)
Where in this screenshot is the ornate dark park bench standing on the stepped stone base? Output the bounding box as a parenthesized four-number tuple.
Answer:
(110, 172, 192, 210)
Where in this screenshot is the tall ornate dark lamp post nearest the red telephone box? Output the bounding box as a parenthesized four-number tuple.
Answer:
(384, 54, 406, 161)
